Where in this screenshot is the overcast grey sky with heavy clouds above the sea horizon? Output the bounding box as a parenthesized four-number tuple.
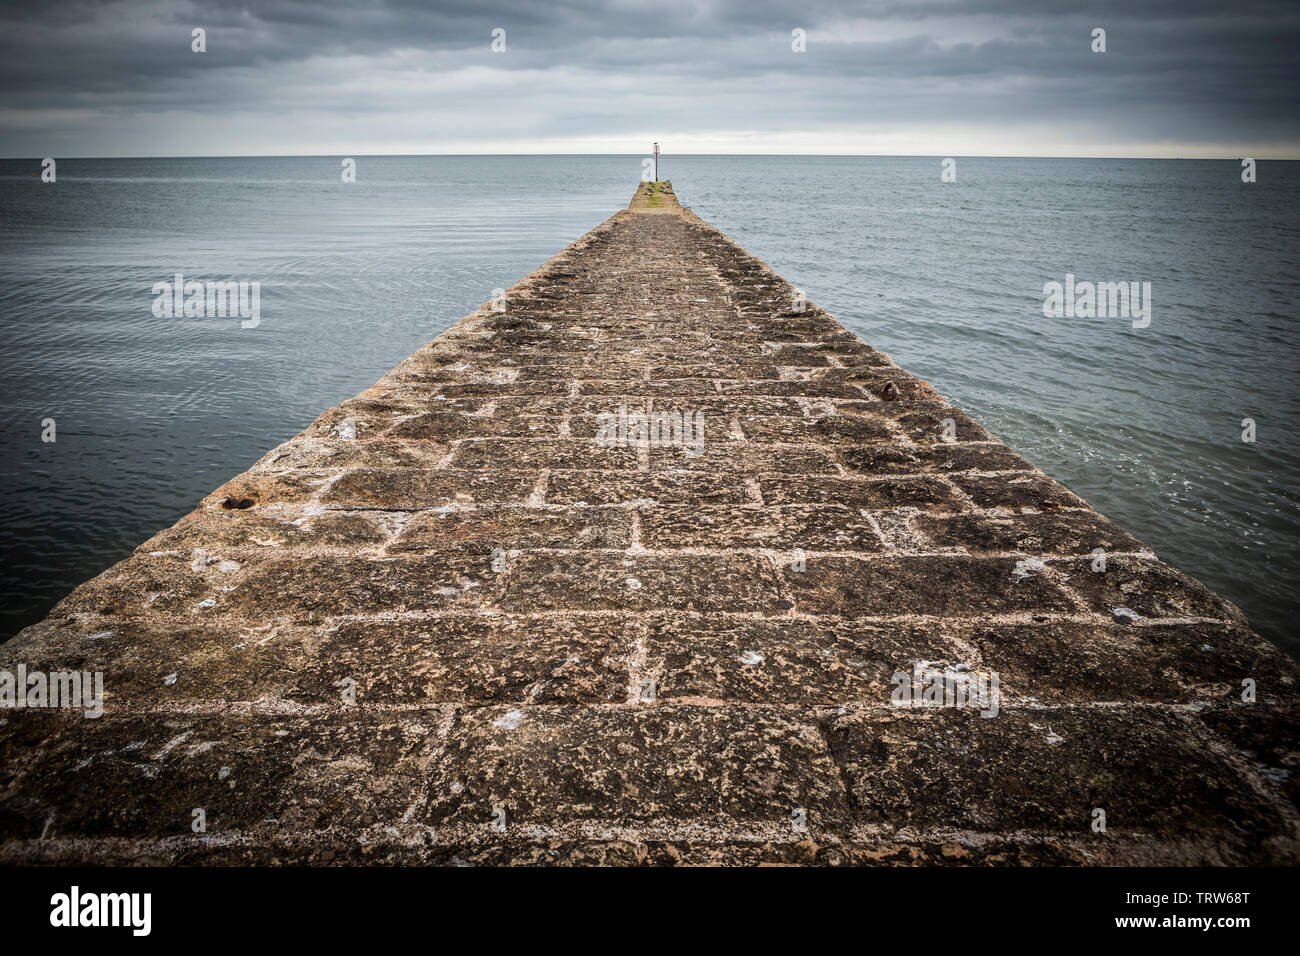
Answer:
(0, 0, 1300, 157)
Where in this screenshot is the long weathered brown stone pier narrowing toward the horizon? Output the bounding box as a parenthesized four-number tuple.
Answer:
(0, 183, 1300, 864)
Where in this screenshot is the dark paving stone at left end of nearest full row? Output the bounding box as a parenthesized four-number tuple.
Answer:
(0, 711, 437, 843)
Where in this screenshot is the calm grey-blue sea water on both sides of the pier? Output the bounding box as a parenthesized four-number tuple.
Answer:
(0, 156, 1300, 654)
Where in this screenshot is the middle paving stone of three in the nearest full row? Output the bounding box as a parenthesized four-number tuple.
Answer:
(425, 705, 848, 834)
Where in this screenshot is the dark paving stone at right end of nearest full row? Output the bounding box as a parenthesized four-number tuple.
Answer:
(828, 708, 1288, 858)
